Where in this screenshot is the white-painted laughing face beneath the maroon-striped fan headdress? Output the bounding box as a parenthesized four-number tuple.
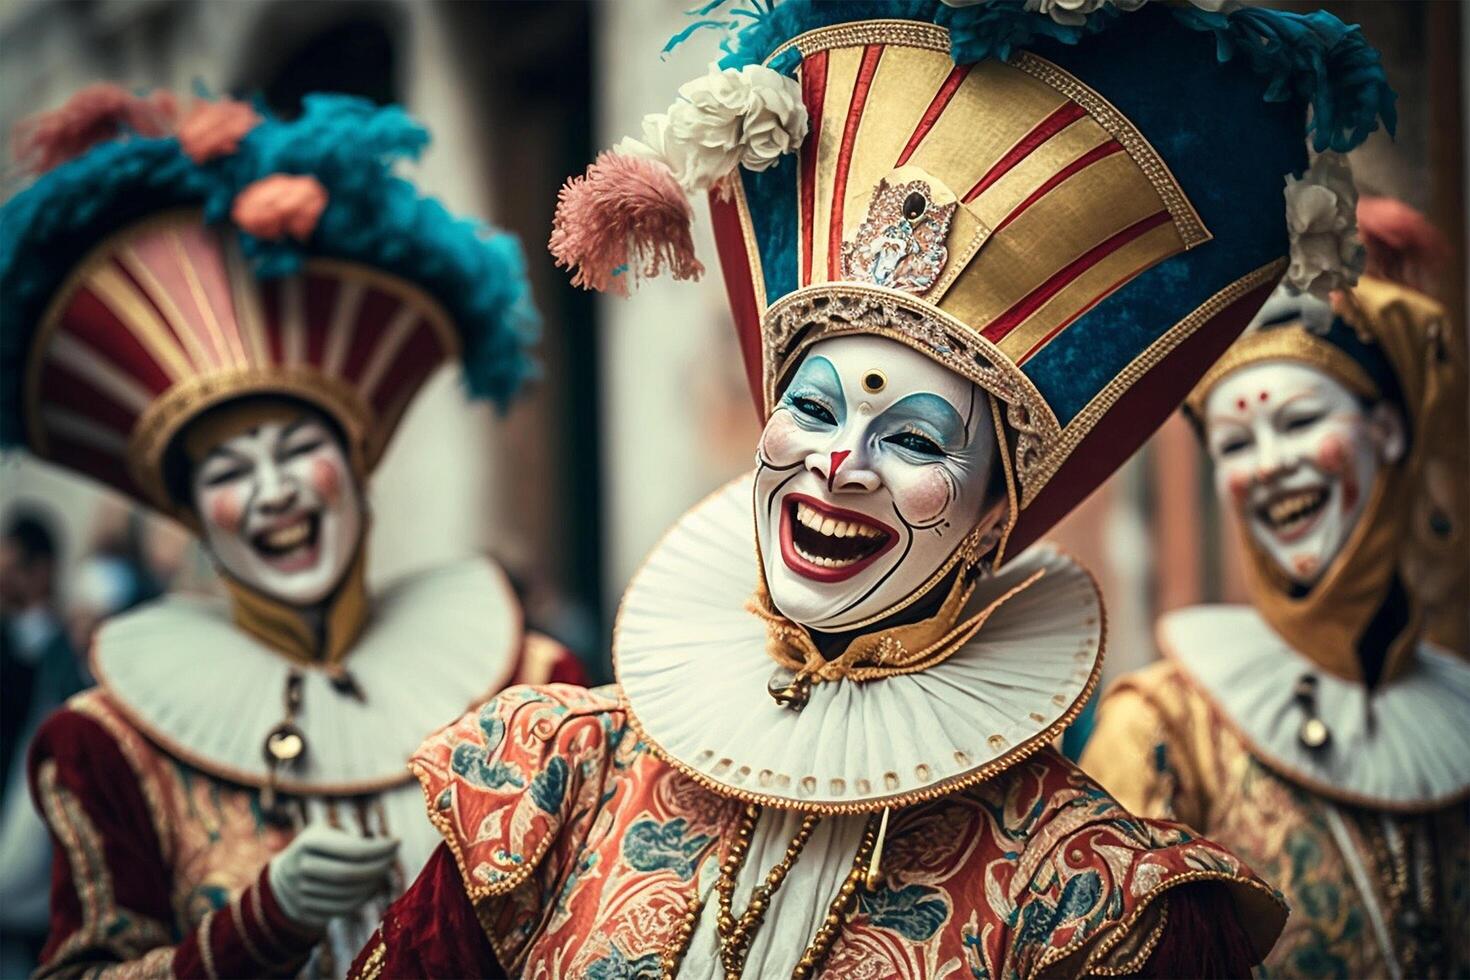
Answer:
(191, 413, 363, 605)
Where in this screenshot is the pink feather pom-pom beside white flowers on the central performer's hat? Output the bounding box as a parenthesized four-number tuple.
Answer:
(550, 151, 704, 295)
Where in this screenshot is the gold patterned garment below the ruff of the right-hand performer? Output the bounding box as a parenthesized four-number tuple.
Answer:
(1082, 660, 1470, 977)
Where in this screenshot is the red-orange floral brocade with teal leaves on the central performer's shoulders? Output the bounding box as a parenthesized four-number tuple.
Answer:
(385, 685, 1285, 979)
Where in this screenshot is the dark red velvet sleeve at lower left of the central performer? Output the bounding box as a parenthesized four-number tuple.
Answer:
(347, 843, 509, 980)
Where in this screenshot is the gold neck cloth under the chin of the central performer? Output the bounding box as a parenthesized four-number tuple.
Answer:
(747, 569, 1045, 683)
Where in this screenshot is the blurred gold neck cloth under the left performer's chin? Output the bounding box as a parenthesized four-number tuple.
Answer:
(225, 547, 369, 666)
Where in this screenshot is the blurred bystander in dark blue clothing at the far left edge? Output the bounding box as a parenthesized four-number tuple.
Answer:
(0, 504, 82, 977)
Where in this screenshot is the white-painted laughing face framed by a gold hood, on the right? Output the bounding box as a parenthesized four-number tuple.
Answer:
(1204, 360, 1404, 586)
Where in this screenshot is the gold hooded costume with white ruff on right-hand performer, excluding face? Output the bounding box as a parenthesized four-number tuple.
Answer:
(1082, 278, 1470, 977)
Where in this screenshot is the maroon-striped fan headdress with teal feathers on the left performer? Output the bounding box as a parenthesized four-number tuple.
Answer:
(0, 85, 535, 519)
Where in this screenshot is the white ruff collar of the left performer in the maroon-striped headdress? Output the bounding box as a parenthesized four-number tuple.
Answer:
(91, 558, 522, 796)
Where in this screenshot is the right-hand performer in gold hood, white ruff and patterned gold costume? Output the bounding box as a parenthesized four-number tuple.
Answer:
(1082, 245, 1470, 980)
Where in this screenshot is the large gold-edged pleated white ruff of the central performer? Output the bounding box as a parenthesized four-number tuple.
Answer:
(613, 475, 1104, 813)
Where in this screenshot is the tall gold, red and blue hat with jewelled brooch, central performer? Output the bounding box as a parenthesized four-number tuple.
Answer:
(553, 0, 1394, 564)
